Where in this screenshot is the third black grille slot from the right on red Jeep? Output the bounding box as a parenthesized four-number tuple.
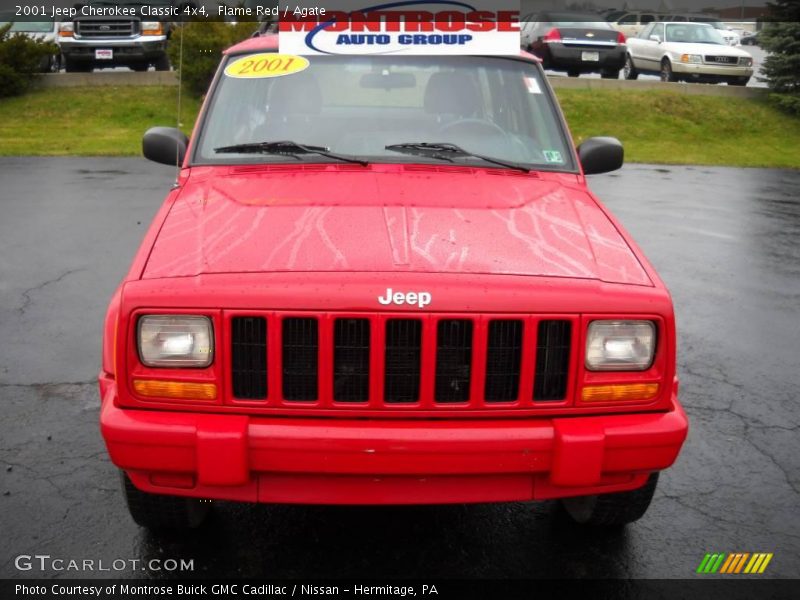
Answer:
(434, 319, 472, 403)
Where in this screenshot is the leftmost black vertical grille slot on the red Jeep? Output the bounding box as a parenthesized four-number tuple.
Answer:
(231, 317, 267, 400)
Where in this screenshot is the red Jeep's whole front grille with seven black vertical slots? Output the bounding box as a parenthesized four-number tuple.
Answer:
(229, 313, 574, 410)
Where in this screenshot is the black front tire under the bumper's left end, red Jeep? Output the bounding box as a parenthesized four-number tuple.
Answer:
(121, 472, 211, 530)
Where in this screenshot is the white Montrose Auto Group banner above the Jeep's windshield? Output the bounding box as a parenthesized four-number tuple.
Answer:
(279, 0, 520, 55)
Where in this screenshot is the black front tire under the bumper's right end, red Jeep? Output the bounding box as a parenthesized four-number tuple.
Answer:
(561, 472, 658, 527)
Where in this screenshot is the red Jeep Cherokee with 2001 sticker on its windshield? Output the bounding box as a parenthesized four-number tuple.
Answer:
(100, 37, 687, 527)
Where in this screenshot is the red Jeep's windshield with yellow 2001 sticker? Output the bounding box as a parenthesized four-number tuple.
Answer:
(194, 54, 574, 170)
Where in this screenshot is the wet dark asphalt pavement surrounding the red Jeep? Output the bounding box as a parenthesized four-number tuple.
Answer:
(0, 158, 800, 578)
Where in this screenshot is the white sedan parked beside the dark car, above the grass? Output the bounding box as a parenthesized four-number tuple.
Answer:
(624, 22, 753, 85)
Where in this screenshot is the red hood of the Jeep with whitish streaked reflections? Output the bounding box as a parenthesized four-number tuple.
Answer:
(143, 165, 652, 285)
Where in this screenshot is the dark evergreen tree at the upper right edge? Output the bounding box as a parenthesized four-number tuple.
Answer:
(759, 0, 800, 114)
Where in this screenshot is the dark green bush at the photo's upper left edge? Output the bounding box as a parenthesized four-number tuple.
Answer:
(0, 23, 58, 97)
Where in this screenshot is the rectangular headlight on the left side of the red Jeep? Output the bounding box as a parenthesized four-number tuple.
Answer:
(138, 315, 214, 369)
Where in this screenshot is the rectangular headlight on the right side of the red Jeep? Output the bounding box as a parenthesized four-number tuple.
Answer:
(586, 321, 656, 371)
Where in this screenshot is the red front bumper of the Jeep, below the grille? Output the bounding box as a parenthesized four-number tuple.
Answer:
(100, 380, 688, 504)
